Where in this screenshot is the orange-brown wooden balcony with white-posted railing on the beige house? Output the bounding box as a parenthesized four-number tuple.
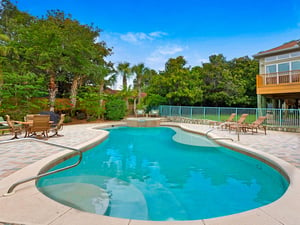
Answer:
(256, 70, 300, 95)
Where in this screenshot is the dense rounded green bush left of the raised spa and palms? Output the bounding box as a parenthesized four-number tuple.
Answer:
(105, 96, 126, 120)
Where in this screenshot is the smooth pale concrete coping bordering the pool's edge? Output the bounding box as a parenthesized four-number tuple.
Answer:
(0, 123, 300, 225)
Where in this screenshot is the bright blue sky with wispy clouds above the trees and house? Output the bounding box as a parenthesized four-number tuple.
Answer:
(12, 0, 300, 70)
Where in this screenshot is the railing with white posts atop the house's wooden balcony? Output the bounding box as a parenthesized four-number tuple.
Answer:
(259, 70, 300, 85)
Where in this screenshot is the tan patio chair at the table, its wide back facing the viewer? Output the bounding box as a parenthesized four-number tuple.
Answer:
(28, 115, 50, 138)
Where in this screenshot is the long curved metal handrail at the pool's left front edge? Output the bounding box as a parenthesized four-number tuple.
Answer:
(0, 138, 82, 195)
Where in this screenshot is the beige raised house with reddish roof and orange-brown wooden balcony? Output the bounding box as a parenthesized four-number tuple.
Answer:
(254, 40, 300, 108)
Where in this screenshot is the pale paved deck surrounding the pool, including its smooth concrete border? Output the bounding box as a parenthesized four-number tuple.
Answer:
(0, 122, 300, 225)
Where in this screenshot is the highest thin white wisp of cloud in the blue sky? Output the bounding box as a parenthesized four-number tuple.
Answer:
(120, 31, 167, 44)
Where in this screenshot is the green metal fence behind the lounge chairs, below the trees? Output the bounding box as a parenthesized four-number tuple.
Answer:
(159, 105, 300, 128)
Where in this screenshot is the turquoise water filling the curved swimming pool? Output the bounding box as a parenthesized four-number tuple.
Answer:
(37, 127, 288, 221)
